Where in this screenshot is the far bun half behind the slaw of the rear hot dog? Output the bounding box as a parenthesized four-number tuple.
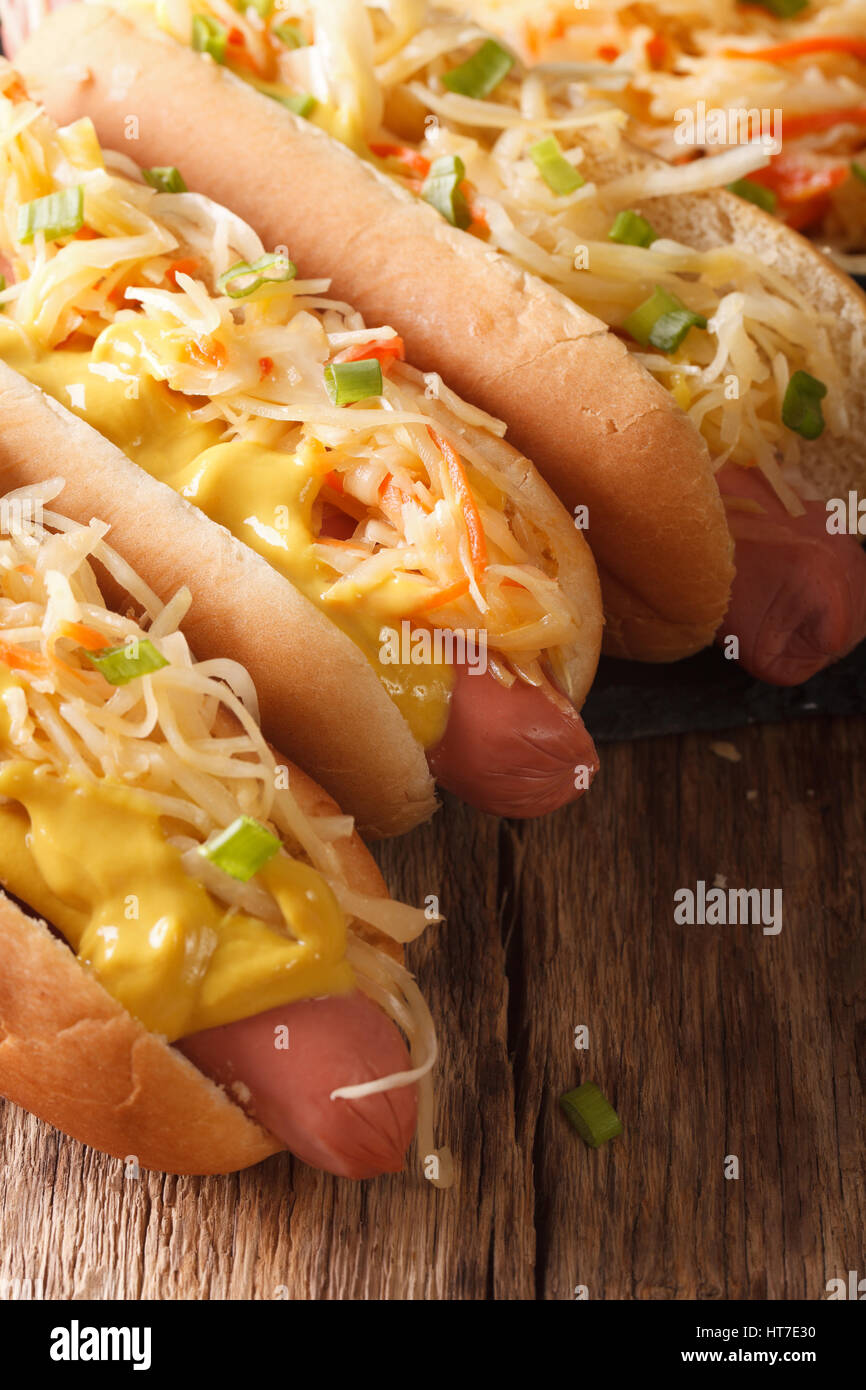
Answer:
(572, 135, 866, 498)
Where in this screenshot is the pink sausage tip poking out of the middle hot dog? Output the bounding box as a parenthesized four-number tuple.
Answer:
(427, 663, 599, 817)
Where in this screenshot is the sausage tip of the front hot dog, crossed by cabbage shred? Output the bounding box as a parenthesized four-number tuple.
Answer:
(175, 991, 418, 1179)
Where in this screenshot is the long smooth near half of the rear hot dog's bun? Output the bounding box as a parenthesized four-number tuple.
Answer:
(15, 6, 733, 660)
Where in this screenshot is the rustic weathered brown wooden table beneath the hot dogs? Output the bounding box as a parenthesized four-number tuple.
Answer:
(0, 720, 866, 1300)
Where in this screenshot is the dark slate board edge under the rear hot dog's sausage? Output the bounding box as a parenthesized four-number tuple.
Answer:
(581, 642, 866, 744)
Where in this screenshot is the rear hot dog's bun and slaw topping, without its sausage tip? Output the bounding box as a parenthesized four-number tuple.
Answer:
(21, 0, 866, 681)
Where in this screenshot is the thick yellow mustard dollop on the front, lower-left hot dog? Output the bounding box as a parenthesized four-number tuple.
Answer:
(0, 750, 354, 1041)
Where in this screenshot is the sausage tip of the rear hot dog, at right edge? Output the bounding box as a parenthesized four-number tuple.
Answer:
(716, 464, 866, 685)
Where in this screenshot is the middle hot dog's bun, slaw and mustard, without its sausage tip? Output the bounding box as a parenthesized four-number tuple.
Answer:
(0, 68, 602, 834)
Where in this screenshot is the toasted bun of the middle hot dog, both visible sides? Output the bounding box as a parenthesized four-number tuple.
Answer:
(0, 344, 602, 835)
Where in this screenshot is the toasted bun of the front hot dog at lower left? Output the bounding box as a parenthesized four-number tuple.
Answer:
(0, 750, 400, 1173)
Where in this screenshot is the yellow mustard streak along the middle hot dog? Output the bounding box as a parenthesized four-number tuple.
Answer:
(0, 318, 453, 748)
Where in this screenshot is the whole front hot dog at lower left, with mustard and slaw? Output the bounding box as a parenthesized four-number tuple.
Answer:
(0, 480, 435, 1179)
